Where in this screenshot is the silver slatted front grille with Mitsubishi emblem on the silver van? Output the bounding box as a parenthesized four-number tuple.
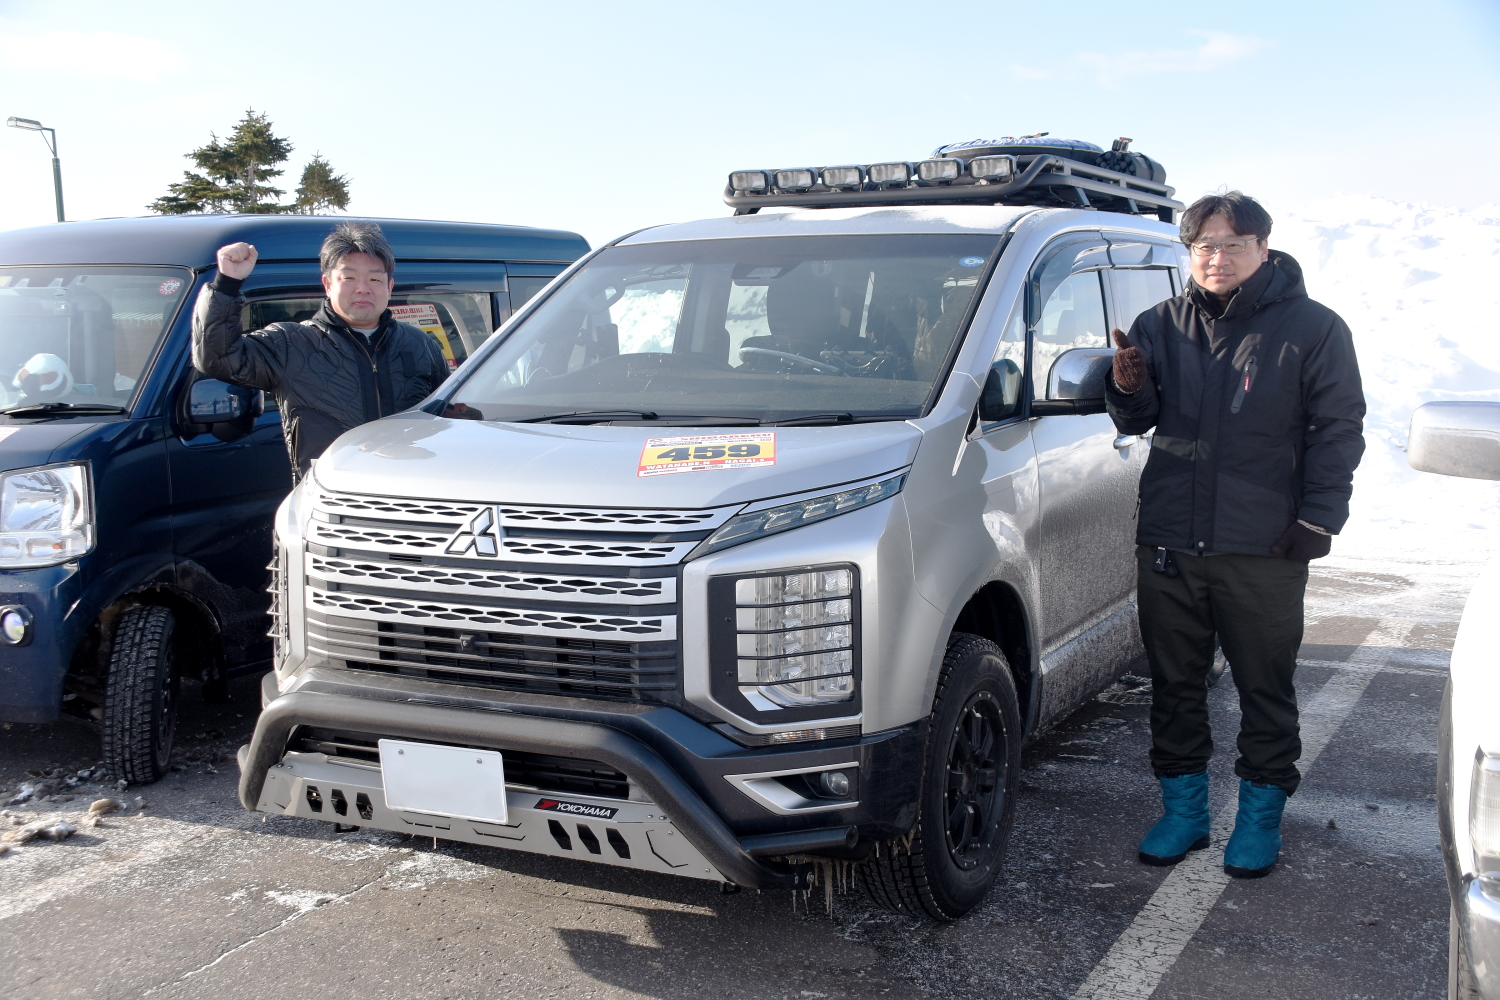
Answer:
(303, 493, 738, 702)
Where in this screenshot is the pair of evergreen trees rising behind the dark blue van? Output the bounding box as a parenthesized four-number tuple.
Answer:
(147, 108, 350, 214)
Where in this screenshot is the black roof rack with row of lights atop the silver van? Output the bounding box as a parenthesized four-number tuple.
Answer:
(725, 153, 1184, 222)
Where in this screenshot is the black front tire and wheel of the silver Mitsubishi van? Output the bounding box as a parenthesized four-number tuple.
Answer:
(860, 633, 1022, 921)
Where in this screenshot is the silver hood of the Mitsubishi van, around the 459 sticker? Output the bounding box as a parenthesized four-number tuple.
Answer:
(315, 412, 921, 508)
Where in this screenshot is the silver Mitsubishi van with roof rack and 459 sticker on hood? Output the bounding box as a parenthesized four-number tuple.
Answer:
(240, 139, 1187, 919)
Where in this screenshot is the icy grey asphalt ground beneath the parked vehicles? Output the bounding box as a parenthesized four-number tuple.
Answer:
(0, 558, 1475, 1000)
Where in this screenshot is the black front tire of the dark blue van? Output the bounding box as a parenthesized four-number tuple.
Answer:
(102, 606, 179, 784)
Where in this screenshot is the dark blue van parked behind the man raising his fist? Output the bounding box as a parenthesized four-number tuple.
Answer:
(0, 216, 588, 783)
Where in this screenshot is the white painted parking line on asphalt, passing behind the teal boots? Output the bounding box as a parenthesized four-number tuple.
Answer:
(1074, 618, 1413, 1000)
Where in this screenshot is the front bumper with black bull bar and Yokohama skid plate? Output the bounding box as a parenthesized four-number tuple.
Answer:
(240, 670, 923, 889)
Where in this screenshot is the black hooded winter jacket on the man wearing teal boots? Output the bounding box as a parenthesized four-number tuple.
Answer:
(1106, 250, 1365, 556)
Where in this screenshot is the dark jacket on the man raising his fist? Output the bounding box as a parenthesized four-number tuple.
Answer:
(192, 276, 449, 480)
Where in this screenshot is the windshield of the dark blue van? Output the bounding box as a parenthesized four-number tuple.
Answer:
(0, 265, 192, 409)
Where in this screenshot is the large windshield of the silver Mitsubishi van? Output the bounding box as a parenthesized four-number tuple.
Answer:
(453, 235, 999, 423)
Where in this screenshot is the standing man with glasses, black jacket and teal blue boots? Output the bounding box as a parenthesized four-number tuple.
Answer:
(1106, 192, 1365, 877)
